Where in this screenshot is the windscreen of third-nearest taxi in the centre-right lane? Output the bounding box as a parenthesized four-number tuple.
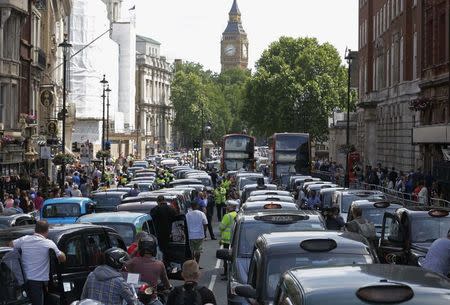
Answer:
(237, 219, 325, 257)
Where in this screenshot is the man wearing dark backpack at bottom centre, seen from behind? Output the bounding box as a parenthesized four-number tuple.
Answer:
(166, 260, 217, 305)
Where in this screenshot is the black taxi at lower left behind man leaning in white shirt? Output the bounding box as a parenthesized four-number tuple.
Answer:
(0, 224, 126, 304)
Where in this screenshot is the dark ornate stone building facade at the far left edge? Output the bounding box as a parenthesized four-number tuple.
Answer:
(0, 0, 72, 176)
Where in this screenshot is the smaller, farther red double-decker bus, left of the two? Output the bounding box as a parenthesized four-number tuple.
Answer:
(221, 134, 255, 172)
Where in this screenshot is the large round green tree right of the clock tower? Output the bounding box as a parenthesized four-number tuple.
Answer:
(242, 37, 347, 140)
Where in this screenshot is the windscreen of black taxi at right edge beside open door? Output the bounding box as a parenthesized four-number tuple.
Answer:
(411, 216, 450, 243)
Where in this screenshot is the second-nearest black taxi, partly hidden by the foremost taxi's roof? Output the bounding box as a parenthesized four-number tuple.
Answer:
(235, 231, 378, 304)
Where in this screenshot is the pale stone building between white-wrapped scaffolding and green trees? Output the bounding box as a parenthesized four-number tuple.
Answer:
(136, 35, 175, 157)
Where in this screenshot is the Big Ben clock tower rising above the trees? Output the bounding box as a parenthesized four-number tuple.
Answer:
(220, 0, 248, 71)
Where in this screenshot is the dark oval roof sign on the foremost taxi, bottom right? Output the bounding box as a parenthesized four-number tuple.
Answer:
(356, 281, 414, 304)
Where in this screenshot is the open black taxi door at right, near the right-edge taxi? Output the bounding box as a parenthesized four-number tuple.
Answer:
(378, 213, 405, 264)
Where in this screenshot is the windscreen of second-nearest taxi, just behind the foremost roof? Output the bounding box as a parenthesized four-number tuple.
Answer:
(265, 252, 373, 300)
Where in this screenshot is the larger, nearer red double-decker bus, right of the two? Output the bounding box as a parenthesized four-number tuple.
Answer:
(268, 133, 311, 185)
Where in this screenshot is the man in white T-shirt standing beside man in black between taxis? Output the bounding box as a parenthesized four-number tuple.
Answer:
(186, 201, 208, 263)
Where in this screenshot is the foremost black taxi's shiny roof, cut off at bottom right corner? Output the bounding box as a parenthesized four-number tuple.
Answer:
(273, 264, 450, 305)
